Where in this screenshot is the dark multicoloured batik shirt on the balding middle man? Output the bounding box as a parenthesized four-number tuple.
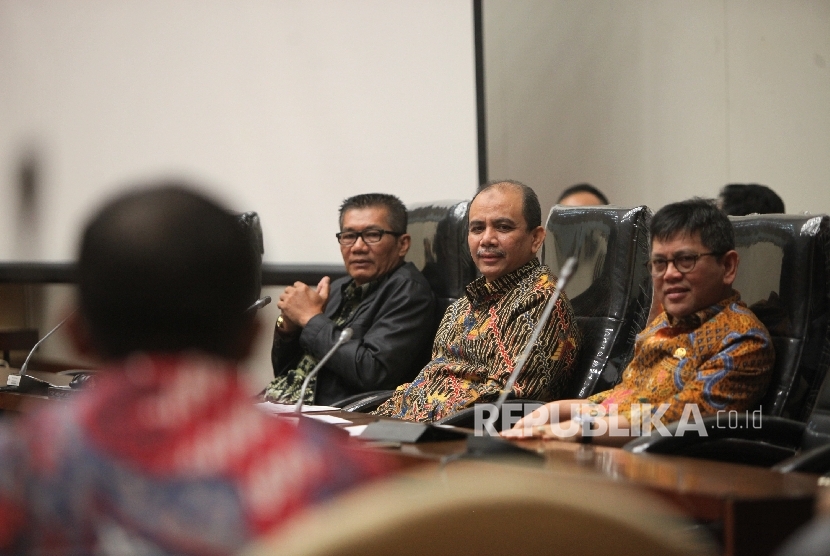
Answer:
(376, 259, 580, 421)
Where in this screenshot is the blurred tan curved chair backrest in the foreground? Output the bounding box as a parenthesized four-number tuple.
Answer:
(242, 462, 716, 556)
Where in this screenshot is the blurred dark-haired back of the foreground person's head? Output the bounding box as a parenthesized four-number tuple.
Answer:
(78, 182, 261, 358)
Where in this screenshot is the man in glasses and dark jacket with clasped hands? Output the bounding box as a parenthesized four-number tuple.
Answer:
(265, 193, 437, 405)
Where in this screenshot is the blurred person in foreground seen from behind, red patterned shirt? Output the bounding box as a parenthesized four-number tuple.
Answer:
(0, 185, 388, 555)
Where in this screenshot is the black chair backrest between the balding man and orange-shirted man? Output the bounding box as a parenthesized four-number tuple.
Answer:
(542, 205, 651, 398)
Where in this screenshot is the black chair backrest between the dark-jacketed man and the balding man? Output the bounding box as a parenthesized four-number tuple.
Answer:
(406, 201, 477, 319)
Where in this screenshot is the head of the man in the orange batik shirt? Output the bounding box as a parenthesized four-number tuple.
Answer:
(649, 198, 738, 318)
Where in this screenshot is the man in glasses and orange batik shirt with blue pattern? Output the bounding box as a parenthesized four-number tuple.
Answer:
(503, 198, 775, 444)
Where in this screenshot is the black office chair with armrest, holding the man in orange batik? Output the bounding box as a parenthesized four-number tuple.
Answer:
(625, 215, 830, 464)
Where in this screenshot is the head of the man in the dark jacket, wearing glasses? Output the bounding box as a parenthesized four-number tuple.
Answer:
(338, 193, 411, 285)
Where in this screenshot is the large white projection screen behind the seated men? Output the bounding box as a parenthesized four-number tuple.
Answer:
(0, 0, 478, 263)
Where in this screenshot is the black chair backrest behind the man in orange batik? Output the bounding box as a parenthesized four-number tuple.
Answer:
(729, 214, 830, 422)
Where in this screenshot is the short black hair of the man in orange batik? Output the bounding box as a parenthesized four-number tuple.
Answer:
(651, 197, 735, 254)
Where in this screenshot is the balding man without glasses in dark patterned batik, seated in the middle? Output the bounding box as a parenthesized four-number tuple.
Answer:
(376, 181, 580, 421)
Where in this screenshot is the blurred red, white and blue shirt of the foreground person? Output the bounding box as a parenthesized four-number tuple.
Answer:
(0, 355, 388, 556)
